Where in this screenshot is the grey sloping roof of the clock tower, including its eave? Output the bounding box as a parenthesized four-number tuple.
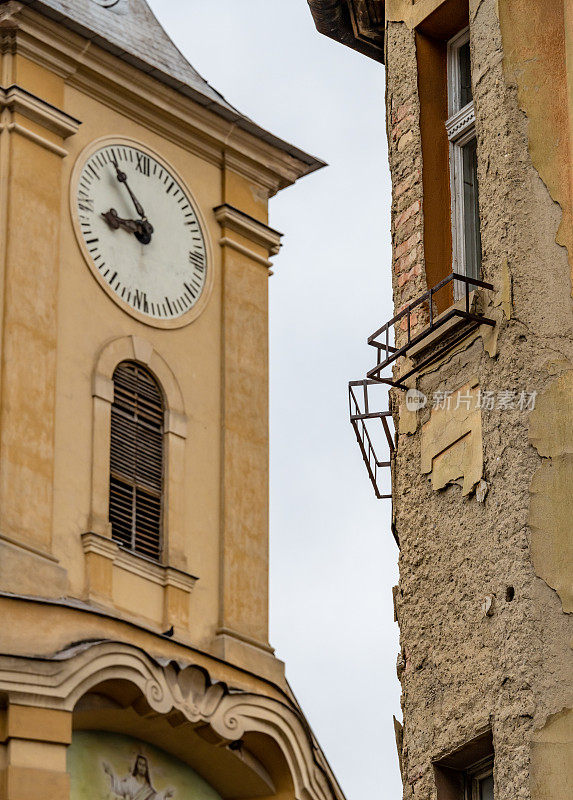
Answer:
(13, 0, 324, 172)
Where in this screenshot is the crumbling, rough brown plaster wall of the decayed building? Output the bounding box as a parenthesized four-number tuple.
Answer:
(387, 0, 573, 800)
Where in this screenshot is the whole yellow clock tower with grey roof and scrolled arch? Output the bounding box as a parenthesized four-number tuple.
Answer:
(0, 0, 343, 800)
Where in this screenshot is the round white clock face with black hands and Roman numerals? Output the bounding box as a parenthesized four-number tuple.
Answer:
(72, 140, 209, 327)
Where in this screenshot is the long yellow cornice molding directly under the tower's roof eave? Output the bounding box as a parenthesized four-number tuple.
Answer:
(0, 8, 324, 195)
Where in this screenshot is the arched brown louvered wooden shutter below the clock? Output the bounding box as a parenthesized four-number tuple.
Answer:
(109, 361, 163, 560)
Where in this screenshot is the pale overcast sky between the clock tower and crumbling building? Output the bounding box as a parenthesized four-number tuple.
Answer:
(148, 0, 401, 800)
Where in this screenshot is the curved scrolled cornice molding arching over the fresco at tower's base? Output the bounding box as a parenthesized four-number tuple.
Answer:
(0, 641, 344, 800)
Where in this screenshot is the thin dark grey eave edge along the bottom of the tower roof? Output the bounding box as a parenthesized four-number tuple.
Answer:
(13, 0, 327, 177)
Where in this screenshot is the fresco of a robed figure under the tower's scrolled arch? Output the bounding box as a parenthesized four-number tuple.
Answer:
(68, 731, 221, 800)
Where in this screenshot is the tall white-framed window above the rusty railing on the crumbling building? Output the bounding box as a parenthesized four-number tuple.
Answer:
(446, 28, 481, 290)
